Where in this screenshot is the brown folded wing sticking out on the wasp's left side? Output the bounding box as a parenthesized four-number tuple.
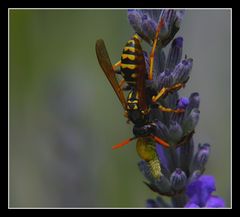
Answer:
(96, 39, 127, 109)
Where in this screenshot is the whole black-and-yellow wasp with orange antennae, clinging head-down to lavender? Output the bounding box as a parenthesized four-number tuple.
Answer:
(96, 19, 188, 148)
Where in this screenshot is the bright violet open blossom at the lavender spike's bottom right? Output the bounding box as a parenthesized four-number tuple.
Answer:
(185, 175, 225, 208)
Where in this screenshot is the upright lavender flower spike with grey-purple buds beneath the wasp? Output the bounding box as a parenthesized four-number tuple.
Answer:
(128, 10, 224, 207)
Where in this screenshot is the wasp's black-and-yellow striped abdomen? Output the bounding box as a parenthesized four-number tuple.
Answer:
(120, 35, 146, 86)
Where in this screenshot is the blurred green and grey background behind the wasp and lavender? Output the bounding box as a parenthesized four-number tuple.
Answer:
(9, 9, 231, 207)
